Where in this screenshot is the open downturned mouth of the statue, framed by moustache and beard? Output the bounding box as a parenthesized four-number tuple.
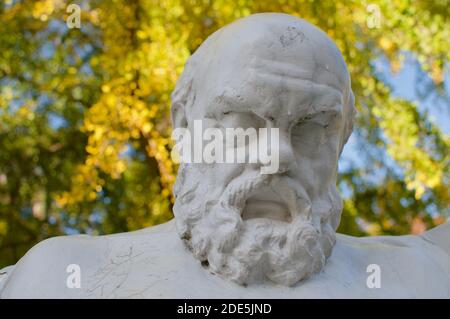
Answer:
(242, 186, 292, 223)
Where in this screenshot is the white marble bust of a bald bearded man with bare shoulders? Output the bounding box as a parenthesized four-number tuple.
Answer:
(0, 13, 450, 298)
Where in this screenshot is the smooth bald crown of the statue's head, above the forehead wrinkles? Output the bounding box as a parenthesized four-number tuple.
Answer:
(196, 13, 349, 91)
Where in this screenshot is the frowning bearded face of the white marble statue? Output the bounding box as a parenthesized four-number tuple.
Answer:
(174, 13, 354, 285)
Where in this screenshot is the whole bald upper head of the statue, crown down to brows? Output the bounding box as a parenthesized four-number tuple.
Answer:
(172, 13, 355, 152)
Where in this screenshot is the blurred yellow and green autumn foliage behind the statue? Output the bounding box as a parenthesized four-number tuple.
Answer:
(0, 0, 450, 267)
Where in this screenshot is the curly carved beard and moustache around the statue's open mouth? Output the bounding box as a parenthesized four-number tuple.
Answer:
(174, 164, 342, 286)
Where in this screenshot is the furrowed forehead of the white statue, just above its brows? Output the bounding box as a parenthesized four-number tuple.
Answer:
(199, 56, 343, 116)
